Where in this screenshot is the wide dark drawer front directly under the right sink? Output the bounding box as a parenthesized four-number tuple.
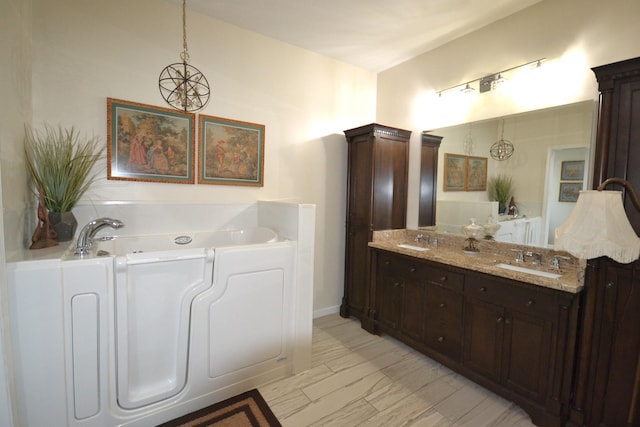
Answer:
(465, 276, 557, 315)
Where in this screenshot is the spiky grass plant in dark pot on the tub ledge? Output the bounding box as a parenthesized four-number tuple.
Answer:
(24, 125, 103, 242)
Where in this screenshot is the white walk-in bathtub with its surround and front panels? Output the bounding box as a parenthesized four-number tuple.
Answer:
(8, 202, 315, 426)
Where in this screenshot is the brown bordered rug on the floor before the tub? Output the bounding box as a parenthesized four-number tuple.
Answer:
(158, 389, 282, 427)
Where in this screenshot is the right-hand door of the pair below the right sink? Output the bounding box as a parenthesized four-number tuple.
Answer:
(501, 311, 553, 403)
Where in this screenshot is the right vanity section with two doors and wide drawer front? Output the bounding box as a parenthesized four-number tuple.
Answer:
(461, 273, 578, 417)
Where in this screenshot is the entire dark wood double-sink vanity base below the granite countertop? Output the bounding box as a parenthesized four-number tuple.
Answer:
(371, 249, 578, 426)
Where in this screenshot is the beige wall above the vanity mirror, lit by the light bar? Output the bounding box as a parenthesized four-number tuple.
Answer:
(377, 0, 640, 229)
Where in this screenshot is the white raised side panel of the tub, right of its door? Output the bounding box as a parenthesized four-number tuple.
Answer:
(192, 243, 294, 388)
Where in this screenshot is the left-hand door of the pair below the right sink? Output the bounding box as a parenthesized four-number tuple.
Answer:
(462, 298, 504, 381)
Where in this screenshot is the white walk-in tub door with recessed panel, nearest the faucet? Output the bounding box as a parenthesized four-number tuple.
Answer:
(115, 249, 213, 409)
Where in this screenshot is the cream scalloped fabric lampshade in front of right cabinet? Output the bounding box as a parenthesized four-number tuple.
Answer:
(554, 190, 640, 264)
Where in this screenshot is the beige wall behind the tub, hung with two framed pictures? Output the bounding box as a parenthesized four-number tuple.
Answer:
(33, 0, 376, 316)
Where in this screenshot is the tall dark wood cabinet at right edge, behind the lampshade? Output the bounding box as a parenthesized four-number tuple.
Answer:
(567, 58, 640, 427)
